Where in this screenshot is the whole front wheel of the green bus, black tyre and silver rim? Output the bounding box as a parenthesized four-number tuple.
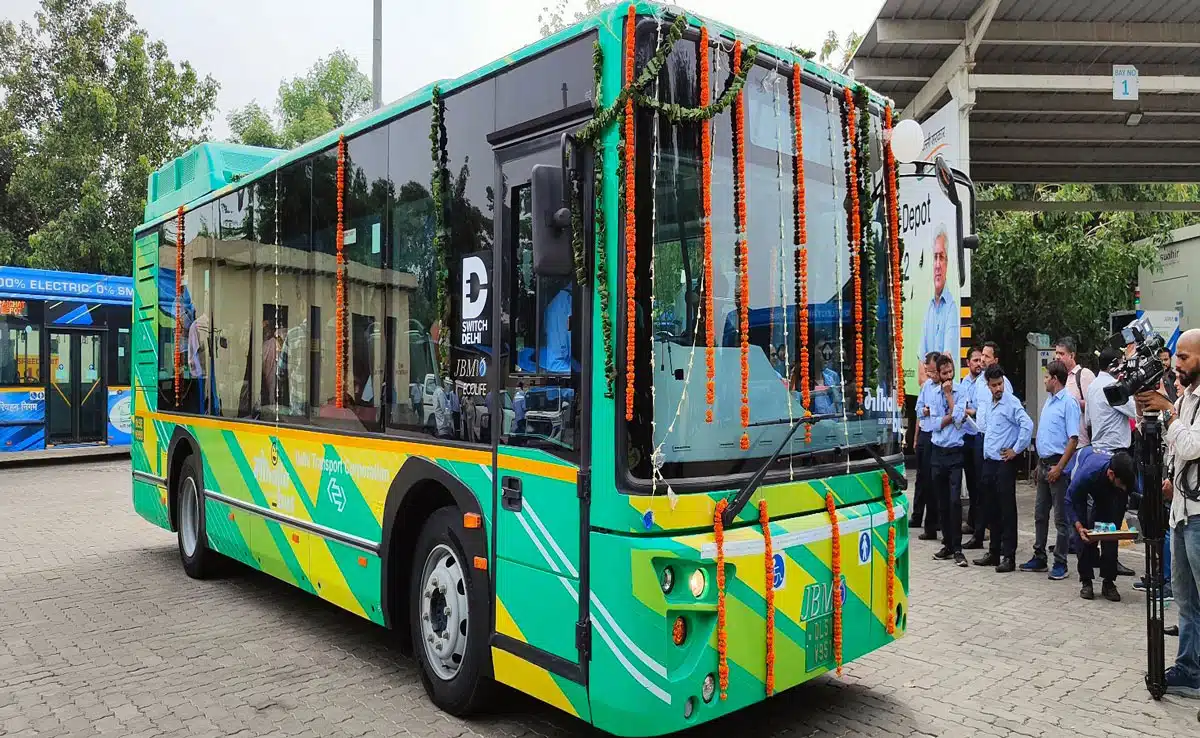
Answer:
(409, 506, 493, 715)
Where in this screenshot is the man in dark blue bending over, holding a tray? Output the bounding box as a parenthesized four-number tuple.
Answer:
(1070, 451, 1138, 602)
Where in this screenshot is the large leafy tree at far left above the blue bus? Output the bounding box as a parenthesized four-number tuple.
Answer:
(0, 0, 217, 274)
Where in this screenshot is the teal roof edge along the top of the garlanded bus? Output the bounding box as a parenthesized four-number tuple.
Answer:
(138, 0, 892, 230)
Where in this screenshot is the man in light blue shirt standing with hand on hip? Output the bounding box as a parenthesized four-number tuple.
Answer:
(972, 366, 1033, 574)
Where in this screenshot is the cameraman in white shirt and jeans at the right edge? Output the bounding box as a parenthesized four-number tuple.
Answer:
(1138, 329, 1200, 697)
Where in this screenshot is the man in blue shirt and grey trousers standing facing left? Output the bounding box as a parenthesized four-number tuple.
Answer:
(1021, 359, 1082, 581)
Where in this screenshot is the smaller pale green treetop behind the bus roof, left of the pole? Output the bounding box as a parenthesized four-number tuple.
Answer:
(227, 49, 371, 149)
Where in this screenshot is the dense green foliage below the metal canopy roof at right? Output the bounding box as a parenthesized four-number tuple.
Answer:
(971, 185, 1200, 385)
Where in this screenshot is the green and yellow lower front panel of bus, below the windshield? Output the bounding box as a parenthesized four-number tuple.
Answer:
(590, 473, 908, 736)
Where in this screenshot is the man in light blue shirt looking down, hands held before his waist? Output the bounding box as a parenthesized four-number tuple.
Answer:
(929, 355, 967, 566)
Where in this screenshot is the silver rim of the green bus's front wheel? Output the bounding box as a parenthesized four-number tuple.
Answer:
(420, 544, 470, 682)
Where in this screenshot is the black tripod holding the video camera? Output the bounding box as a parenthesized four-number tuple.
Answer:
(1136, 413, 1166, 700)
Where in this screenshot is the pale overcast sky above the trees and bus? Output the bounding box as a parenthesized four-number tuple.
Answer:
(2, 0, 883, 139)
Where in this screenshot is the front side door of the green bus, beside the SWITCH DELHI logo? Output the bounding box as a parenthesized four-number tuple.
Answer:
(489, 121, 587, 686)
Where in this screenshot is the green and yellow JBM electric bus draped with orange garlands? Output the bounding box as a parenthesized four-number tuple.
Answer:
(132, 1, 908, 736)
